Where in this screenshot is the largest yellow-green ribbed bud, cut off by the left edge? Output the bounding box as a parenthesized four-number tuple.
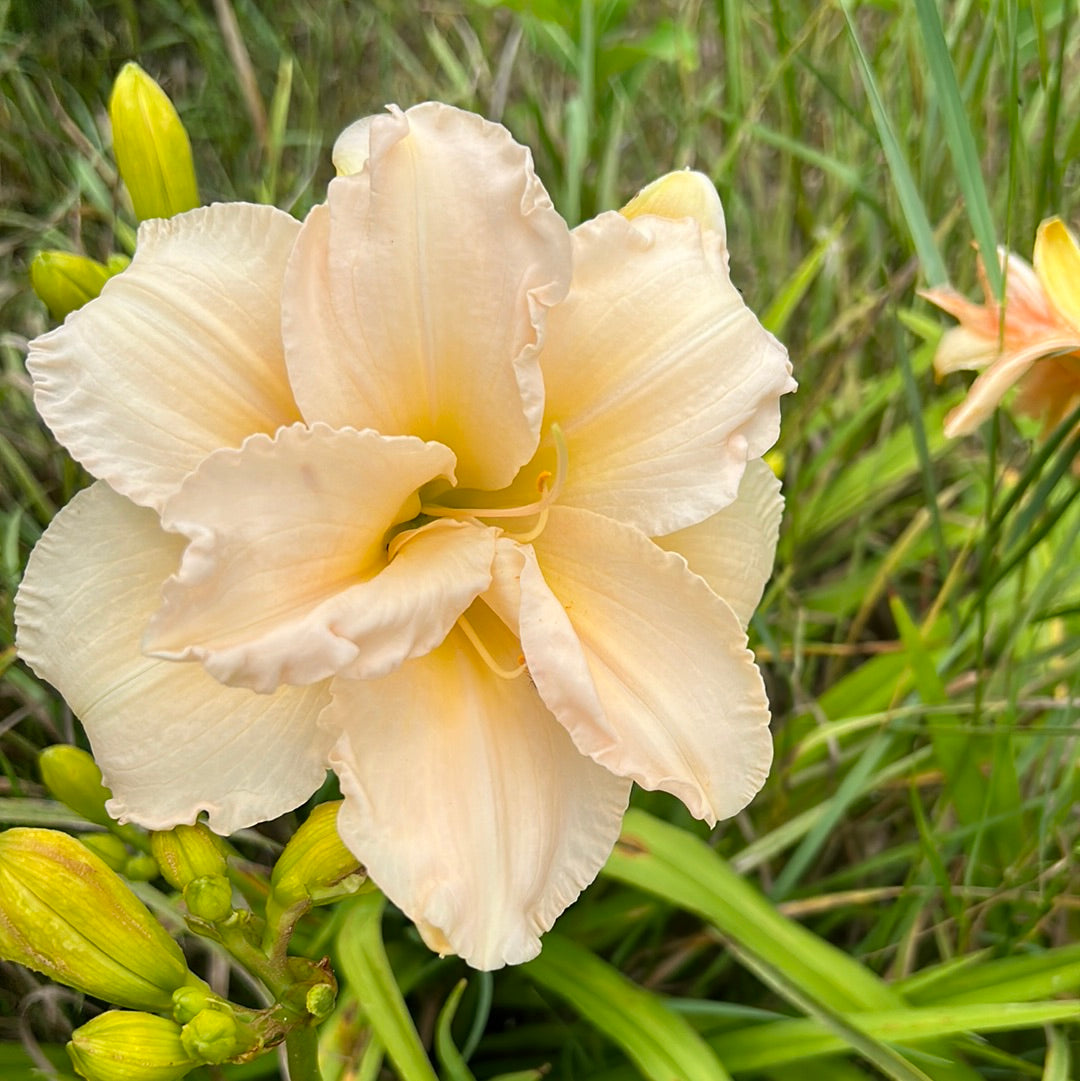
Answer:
(0, 828, 200, 1010)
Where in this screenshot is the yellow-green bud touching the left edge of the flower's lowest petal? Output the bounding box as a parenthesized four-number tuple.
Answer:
(270, 800, 365, 907)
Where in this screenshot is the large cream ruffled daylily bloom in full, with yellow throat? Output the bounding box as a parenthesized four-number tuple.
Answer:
(17, 104, 794, 967)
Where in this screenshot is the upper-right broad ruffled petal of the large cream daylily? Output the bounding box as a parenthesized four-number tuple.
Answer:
(542, 213, 795, 536)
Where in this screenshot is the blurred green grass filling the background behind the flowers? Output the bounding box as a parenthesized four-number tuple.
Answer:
(0, 0, 1080, 1081)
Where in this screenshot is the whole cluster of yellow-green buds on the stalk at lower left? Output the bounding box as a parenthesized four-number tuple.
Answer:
(0, 746, 364, 1081)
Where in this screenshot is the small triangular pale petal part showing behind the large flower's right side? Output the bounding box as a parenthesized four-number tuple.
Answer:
(656, 458, 784, 629)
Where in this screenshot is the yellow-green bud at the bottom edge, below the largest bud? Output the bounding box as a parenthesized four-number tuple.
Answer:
(67, 1010, 199, 1081)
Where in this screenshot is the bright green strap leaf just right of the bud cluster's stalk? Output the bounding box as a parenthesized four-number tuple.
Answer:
(337, 891, 438, 1081)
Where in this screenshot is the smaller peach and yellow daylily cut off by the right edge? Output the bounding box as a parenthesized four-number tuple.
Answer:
(922, 217, 1080, 437)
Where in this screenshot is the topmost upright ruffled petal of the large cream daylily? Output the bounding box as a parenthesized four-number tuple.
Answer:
(283, 104, 570, 489)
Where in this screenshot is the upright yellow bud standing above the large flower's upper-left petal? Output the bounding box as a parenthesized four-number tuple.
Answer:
(109, 64, 199, 221)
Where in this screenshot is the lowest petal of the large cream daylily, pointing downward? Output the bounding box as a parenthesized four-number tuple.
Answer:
(324, 629, 630, 969)
